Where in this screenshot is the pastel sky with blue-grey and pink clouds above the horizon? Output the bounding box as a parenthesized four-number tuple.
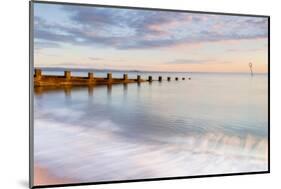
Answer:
(34, 3, 268, 73)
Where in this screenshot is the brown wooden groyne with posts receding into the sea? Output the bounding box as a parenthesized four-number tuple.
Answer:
(34, 69, 190, 87)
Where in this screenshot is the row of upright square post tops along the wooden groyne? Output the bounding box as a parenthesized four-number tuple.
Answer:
(35, 69, 191, 82)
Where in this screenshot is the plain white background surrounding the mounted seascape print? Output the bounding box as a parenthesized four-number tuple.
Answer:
(0, 0, 276, 189)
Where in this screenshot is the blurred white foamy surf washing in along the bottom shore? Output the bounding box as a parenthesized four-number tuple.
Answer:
(34, 117, 267, 182)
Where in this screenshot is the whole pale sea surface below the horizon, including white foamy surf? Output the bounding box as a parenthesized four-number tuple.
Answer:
(34, 72, 268, 182)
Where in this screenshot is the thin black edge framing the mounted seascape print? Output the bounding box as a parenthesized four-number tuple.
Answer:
(29, 1, 270, 188)
